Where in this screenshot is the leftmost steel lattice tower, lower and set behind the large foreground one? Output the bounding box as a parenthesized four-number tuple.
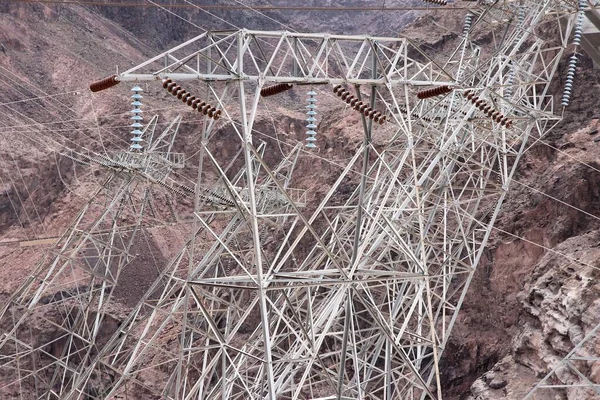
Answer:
(0, 117, 193, 399)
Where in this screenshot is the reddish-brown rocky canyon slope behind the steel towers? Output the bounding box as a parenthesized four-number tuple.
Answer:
(0, 0, 600, 400)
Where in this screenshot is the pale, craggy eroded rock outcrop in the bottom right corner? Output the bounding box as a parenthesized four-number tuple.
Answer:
(469, 231, 600, 400)
